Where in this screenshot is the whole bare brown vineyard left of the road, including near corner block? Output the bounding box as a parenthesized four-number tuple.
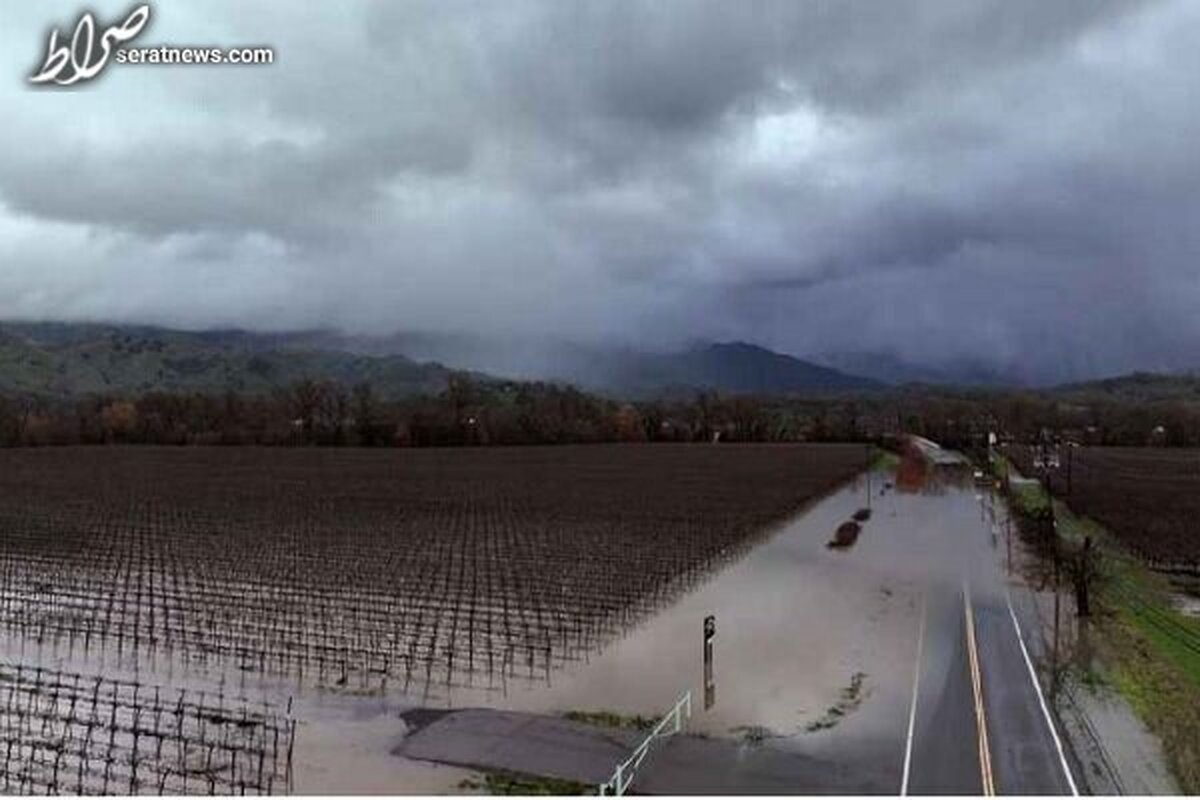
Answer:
(0, 445, 868, 793)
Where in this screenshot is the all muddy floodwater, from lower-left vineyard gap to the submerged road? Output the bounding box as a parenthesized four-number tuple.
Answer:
(4, 455, 1060, 794)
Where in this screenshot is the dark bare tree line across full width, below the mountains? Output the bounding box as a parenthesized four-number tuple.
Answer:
(0, 373, 1200, 449)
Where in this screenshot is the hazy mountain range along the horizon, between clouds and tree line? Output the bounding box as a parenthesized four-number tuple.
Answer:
(0, 323, 1200, 399)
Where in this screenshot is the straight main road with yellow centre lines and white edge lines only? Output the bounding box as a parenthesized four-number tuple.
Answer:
(901, 443, 1079, 795)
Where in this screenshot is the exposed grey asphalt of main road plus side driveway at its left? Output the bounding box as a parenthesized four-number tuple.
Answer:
(397, 563, 1074, 795)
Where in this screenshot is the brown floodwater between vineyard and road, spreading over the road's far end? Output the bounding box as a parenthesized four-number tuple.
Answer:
(417, 455, 1046, 780)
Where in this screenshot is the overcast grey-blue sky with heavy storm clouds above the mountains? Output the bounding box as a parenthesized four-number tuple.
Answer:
(0, 0, 1200, 381)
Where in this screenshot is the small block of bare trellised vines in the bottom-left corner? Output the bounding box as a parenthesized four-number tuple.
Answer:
(0, 663, 294, 795)
